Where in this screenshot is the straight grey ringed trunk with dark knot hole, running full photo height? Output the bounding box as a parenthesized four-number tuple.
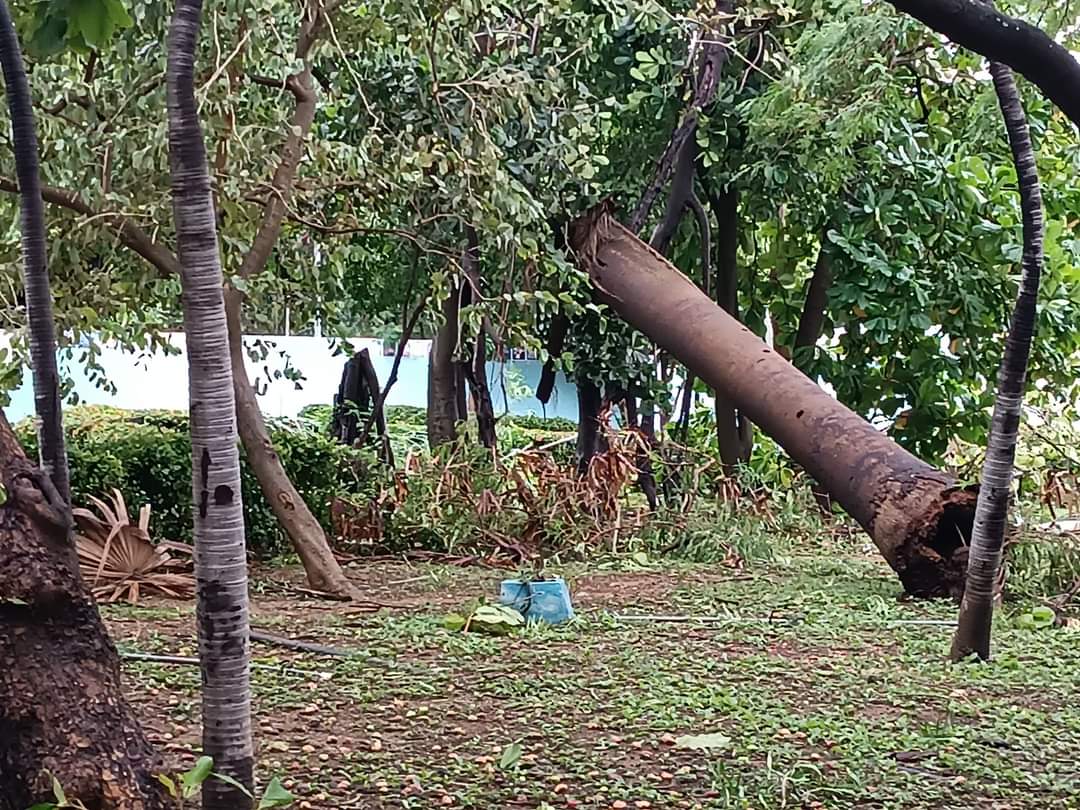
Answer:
(166, 0, 255, 810)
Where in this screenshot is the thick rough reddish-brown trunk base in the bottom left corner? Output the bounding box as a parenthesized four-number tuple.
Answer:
(0, 414, 165, 810)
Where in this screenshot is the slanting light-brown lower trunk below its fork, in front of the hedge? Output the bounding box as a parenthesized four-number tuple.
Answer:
(225, 287, 360, 598)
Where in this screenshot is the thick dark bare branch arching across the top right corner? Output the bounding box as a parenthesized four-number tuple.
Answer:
(889, 0, 1080, 126)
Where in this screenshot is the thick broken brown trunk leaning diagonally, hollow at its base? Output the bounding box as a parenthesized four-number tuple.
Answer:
(571, 205, 975, 596)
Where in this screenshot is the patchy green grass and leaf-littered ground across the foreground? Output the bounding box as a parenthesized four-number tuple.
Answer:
(105, 546, 1080, 810)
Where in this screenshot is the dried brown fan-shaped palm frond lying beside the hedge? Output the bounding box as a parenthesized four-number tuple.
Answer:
(71, 489, 195, 603)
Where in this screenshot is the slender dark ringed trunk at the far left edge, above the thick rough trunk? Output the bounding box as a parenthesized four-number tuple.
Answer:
(0, 0, 71, 502)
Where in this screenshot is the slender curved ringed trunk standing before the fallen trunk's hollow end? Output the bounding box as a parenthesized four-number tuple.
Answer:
(953, 62, 1043, 661)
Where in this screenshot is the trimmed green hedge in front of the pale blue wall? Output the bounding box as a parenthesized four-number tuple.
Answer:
(16, 406, 364, 556)
